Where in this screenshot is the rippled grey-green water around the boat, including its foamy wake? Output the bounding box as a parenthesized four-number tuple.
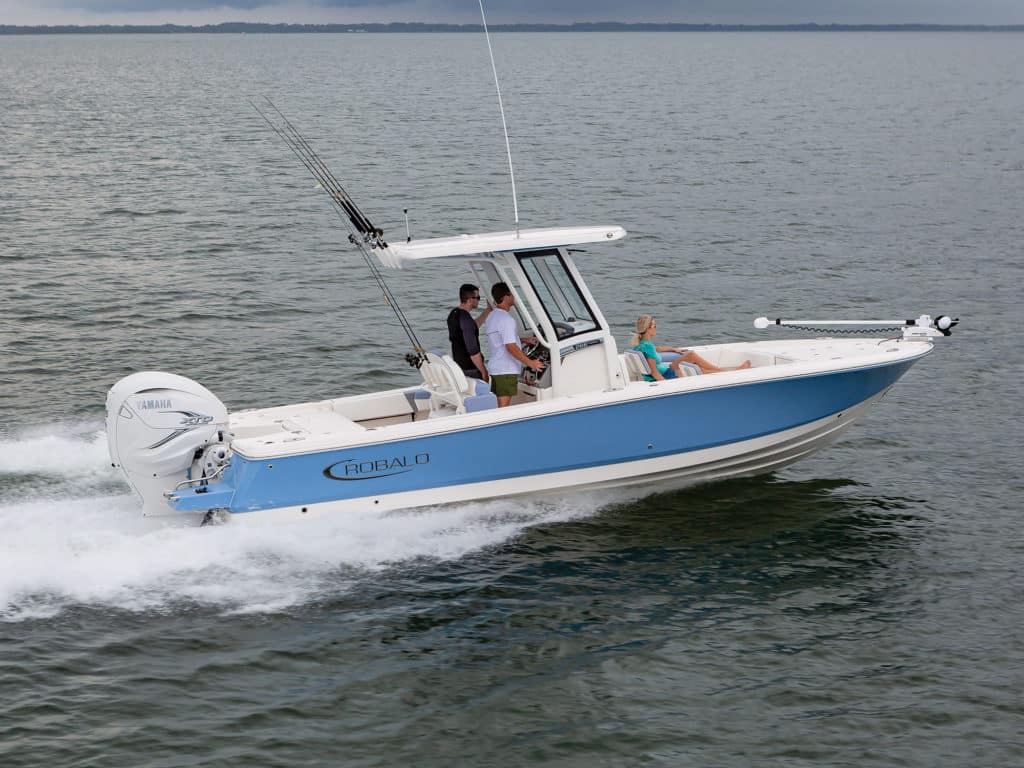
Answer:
(0, 33, 1024, 768)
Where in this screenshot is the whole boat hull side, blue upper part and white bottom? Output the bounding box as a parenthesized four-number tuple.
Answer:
(169, 355, 920, 517)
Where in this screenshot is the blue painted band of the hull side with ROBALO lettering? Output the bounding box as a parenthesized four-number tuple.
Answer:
(172, 359, 915, 513)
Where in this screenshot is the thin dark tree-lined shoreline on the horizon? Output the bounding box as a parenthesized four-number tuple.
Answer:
(0, 22, 1024, 35)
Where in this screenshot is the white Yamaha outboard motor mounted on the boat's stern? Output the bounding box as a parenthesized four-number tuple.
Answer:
(106, 371, 230, 516)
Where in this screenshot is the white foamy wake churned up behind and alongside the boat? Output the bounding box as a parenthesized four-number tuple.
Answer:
(0, 428, 608, 622)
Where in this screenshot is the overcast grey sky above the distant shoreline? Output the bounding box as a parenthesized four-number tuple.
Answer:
(0, 0, 1024, 25)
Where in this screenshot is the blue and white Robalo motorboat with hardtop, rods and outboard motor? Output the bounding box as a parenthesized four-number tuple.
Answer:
(99, 33, 956, 522)
